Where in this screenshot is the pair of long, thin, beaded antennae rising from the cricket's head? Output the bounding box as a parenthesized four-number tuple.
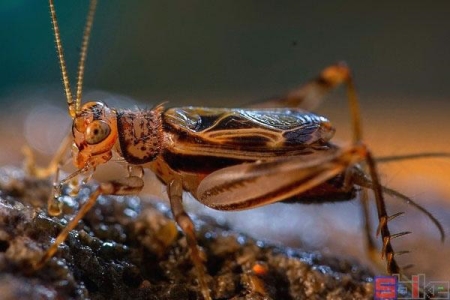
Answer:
(49, 0, 97, 119)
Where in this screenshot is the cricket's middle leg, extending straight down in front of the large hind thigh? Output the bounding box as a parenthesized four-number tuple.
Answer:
(167, 179, 211, 300)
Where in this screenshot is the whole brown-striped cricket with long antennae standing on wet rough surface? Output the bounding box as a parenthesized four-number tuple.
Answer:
(29, 0, 445, 299)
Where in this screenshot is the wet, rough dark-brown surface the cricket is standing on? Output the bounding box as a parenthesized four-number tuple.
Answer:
(0, 167, 373, 299)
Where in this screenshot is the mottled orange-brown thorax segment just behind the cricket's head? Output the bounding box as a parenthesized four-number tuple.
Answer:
(117, 106, 163, 165)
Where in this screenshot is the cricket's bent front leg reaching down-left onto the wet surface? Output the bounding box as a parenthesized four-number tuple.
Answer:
(34, 176, 144, 269)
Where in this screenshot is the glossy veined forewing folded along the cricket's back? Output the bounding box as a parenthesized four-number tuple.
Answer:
(165, 107, 334, 149)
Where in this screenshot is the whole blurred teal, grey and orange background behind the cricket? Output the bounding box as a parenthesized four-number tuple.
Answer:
(0, 0, 450, 281)
